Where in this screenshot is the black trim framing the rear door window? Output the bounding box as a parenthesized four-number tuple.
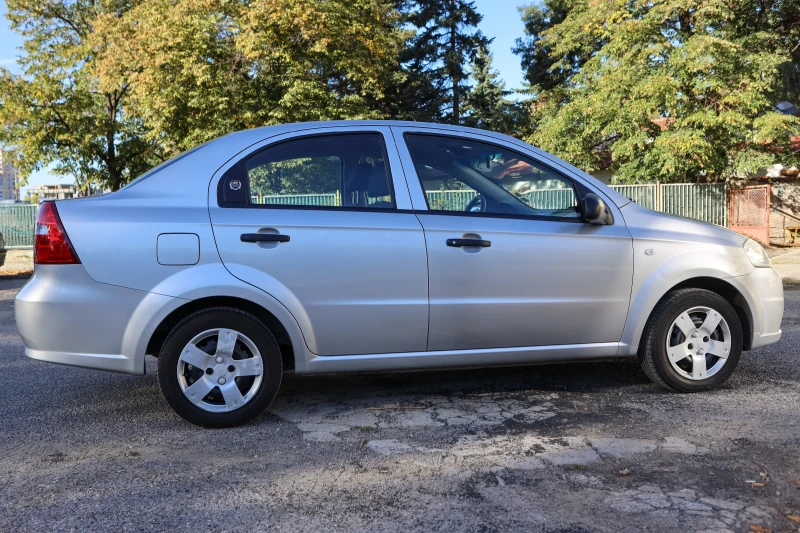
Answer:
(217, 130, 398, 213)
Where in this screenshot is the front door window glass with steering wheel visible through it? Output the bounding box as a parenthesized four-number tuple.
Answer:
(405, 134, 581, 219)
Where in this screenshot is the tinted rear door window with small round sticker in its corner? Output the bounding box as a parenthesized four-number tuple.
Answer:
(220, 133, 395, 209)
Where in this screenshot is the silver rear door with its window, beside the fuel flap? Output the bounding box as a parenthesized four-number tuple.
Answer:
(209, 127, 428, 355)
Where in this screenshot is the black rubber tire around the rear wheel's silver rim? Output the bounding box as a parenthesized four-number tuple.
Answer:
(158, 307, 283, 428)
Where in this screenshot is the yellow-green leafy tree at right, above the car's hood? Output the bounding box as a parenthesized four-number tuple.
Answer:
(530, 0, 800, 181)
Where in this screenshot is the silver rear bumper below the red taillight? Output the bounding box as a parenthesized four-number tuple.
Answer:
(14, 265, 175, 374)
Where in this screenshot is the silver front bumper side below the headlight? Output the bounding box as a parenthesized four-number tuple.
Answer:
(731, 268, 783, 349)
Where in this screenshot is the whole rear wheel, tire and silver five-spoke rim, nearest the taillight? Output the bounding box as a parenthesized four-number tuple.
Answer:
(158, 307, 283, 428)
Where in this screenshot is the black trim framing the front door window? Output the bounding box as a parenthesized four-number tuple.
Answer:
(403, 131, 588, 224)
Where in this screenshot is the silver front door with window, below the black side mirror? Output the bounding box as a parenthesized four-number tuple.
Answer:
(395, 128, 633, 350)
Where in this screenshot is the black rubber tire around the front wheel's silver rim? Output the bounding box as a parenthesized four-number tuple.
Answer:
(639, 289, 742, 392)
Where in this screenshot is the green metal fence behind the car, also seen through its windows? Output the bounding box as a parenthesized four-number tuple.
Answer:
(0, 183, 728, 248)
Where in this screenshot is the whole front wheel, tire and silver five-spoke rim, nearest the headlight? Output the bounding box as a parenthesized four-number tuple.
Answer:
(639, 289, 742, 392)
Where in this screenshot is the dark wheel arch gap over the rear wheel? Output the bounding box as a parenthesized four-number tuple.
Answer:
(145, 296, 295, 370)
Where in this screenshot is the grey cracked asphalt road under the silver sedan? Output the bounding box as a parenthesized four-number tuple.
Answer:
(0, 281, 800, 532)
